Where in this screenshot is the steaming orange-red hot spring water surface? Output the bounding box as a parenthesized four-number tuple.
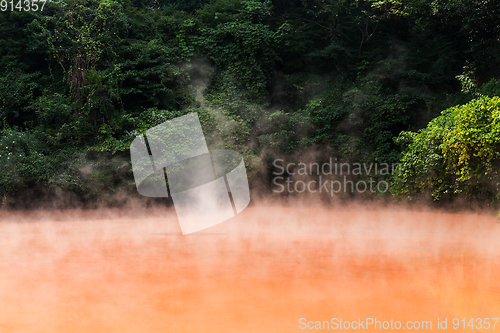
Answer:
(0, 205, 500, 333)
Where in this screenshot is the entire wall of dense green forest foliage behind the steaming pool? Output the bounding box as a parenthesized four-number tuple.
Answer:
(0, 0, 500, 203)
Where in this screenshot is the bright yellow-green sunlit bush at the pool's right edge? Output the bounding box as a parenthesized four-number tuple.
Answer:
(394, 97, 500, 202)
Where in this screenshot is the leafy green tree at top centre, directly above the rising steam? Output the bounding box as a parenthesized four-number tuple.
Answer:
(194, 0, 278, 98)
